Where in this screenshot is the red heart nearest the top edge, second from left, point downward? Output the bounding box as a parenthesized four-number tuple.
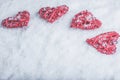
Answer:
(39, 5, 69, 23)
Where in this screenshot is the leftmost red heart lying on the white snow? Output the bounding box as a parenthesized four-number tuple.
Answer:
(1, 11, 30, 28)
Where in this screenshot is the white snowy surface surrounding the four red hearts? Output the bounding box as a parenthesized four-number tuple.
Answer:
(0, 0, 120, 80)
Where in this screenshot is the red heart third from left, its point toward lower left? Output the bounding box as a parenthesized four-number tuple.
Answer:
(71, 10, 102, 30)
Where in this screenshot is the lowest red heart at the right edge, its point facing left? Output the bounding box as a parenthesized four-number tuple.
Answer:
(86, 31, 120, 55)
